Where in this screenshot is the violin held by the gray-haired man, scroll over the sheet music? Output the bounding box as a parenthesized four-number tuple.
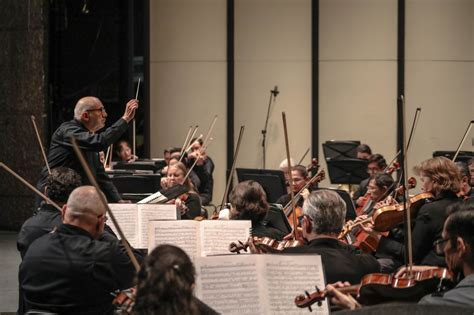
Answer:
(229, 236, 305, 254)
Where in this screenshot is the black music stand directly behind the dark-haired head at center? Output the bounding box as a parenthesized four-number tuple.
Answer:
(236, 168, 287, 203)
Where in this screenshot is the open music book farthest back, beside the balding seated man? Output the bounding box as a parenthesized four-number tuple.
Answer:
(107, 203, 180, 248)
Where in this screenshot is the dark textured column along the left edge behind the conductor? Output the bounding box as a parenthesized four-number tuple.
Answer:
(0, 0, 48, 230)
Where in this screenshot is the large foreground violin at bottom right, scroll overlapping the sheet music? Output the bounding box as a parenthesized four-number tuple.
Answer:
(295, 268, 454, 310)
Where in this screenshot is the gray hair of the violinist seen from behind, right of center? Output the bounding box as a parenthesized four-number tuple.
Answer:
(303, 189, 346, 234)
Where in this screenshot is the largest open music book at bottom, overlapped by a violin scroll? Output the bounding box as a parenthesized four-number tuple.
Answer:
(194, 254, 329, 315)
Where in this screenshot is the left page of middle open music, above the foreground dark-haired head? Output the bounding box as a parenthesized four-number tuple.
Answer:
(148, 220, 200, 261)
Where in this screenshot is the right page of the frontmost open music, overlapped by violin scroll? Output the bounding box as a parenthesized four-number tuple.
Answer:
(260, 255, 329, 315)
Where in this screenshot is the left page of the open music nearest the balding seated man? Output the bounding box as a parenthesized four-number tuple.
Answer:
(107, 203, 138, 247)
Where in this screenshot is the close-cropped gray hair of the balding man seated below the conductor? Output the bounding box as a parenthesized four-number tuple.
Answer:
(66, 186, 105, 221)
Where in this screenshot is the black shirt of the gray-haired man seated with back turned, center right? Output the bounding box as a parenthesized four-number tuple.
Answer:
(283, 237, 380, 284)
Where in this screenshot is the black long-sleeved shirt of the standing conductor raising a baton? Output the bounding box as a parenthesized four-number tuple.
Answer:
(38, 119, 128, 202)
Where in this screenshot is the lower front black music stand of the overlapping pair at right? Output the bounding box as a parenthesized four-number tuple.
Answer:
(326, 159, 369, 184)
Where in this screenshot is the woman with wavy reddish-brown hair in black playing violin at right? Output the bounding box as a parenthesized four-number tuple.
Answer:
(377, 157, 460, 266)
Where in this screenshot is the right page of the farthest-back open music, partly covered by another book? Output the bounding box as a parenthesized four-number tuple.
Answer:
(137, 204, 178, 248)
